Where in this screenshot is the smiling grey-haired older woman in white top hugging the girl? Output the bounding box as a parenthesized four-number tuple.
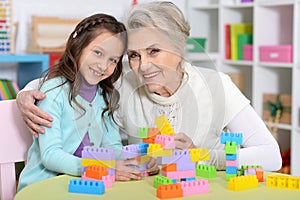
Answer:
(17, 2, 281, 177)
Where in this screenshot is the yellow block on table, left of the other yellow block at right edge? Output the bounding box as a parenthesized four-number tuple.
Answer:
(228, 175, 258, 191)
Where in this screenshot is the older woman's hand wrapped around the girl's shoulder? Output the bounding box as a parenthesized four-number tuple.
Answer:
(16, 90, 53, 137)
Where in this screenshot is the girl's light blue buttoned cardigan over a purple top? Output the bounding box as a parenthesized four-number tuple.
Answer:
(18, 78, 122, 191)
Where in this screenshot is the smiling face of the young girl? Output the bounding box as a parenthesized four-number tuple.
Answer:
(79, 29, 125, 85)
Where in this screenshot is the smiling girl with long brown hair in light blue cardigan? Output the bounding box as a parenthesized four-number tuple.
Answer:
(18, 14, 127, 190)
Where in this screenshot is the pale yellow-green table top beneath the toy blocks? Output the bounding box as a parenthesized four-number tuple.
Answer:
(15, 171, 300, 200)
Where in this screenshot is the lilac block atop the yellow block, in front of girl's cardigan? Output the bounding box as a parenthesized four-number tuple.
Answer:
(82, 146, 115, 160)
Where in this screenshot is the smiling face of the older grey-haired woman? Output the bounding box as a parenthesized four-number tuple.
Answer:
(127, 28, 183, 96)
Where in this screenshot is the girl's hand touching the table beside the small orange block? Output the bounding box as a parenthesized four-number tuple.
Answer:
(116, 160, 141, 181)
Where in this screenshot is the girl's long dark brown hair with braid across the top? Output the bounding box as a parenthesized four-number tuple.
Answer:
(44, 14, 127, 122)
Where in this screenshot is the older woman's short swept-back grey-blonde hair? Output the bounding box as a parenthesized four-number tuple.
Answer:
(124, 1, 190, 55)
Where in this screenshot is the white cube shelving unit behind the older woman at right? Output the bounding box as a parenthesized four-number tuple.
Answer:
(188, 0, 300, 176)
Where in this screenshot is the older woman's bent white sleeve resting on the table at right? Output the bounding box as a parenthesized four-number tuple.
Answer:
(227, 105, 282, 171)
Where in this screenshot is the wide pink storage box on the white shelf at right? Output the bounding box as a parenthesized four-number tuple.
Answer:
(259, 45, 293, 63)
